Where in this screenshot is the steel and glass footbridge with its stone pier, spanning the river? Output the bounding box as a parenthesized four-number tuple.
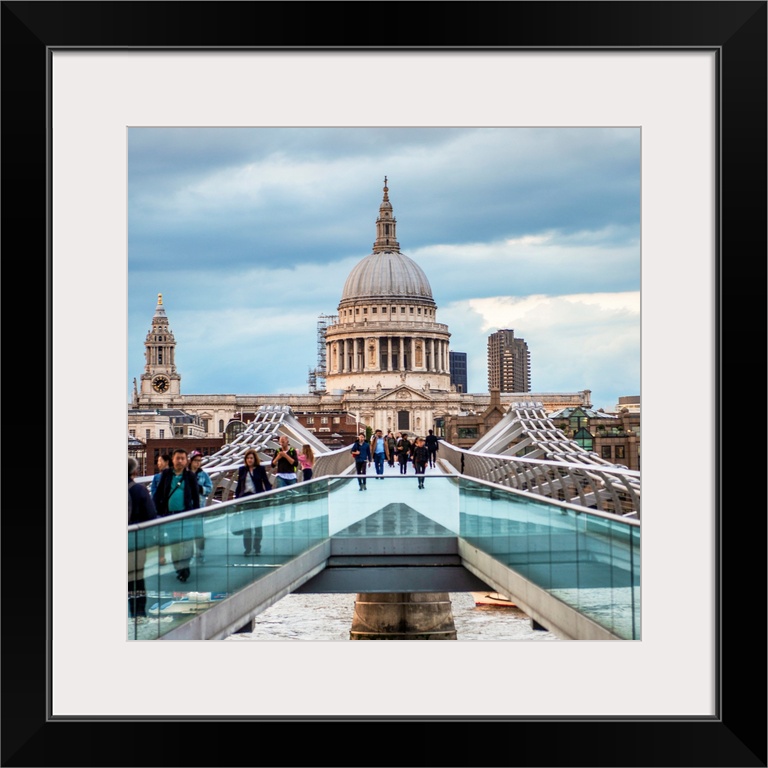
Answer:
(128, 403, 641, 640)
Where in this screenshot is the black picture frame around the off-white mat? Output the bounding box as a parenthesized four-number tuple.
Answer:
(0, 0, 767, 768)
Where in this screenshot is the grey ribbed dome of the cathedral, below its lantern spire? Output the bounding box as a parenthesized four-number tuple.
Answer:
(341, 251, 433, 304)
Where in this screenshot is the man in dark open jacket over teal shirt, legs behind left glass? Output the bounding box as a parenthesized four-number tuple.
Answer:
(154, 448, 202, 582)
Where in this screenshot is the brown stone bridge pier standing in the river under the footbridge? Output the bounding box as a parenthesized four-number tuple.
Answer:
(349, 592, 456, 640)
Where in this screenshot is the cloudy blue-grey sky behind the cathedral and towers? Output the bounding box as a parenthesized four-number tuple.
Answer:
(128, 128, 640, 410)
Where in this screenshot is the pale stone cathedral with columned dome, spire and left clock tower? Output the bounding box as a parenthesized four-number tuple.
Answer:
(129, 178, 591, 441)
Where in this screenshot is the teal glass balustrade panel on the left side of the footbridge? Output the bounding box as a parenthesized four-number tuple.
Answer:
(128, 478, 328, 640)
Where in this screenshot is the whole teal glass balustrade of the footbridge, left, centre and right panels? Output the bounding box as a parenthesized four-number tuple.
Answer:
(128, 473, 640, 639)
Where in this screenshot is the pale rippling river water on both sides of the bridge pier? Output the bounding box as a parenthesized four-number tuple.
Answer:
(226, 592, 560, 642)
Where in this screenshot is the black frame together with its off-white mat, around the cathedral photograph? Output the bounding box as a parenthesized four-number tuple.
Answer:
(1, 2, 766, 766)
